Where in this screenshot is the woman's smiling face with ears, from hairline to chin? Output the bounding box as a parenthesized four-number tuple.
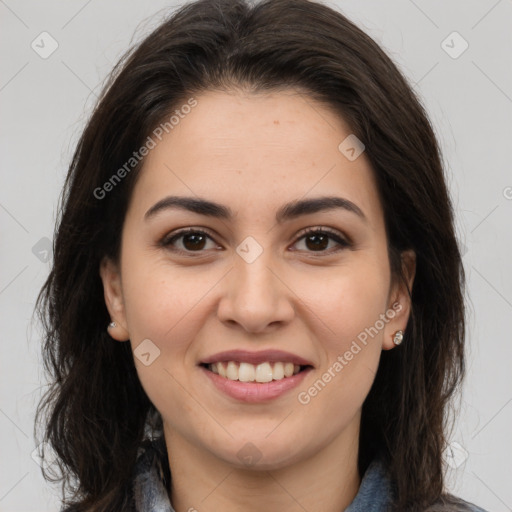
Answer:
(101, 90, 412, 468)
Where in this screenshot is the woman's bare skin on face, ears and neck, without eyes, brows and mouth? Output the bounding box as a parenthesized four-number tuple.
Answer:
(100, 89, 415, 512)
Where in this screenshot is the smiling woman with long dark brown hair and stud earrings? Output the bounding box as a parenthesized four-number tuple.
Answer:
(38, 0, 488, 512)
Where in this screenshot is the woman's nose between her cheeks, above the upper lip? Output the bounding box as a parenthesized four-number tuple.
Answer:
(217, 246, 295, 333)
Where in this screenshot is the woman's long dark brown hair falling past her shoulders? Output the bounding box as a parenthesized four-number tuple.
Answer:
(36, 0, 465, 512)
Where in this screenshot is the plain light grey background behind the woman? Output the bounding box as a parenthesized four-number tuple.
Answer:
(0, 0, 512, 512)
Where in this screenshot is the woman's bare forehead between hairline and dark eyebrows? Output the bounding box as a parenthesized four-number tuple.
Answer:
(130, 90, 382, 227)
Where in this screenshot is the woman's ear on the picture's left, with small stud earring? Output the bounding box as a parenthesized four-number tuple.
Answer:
(99, 257, 130, 341)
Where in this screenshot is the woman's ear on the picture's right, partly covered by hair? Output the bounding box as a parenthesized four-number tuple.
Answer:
(382, 249, 416, 350)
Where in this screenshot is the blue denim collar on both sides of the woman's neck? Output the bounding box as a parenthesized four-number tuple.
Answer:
(133, 437, 391, 512)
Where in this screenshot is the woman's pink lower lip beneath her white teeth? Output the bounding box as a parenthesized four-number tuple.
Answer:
(200, 366, 312, 403)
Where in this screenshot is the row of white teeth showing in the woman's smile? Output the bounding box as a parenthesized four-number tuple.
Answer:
(208, 361, 300, 382)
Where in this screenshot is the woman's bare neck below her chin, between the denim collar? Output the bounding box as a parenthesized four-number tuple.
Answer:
(164, 418, 361, 512)
